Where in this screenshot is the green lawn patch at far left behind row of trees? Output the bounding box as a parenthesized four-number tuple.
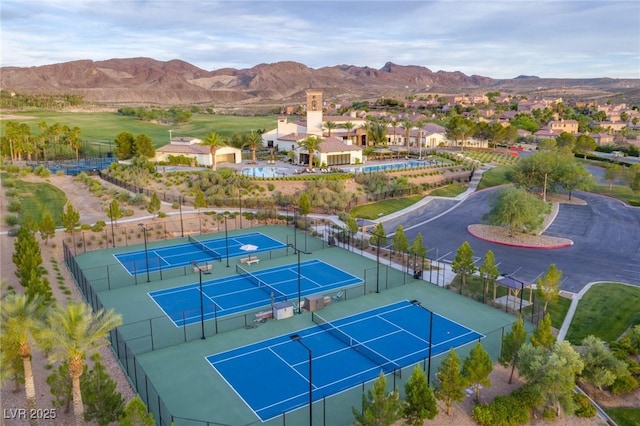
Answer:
(10, 180, 67, 226)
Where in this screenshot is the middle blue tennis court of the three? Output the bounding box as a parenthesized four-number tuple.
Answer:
(149, 259, 362, 327)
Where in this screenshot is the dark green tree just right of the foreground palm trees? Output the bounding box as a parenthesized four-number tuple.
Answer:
(80, 354, 124, 426)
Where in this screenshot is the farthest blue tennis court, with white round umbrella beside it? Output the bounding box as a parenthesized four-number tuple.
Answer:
(114, 232, 286, 275)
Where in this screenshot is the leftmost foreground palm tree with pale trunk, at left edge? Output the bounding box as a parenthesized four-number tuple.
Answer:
(1, 293, 47, 424)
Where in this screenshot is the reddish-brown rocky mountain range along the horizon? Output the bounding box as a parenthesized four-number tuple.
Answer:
(0, 58, 640, 106)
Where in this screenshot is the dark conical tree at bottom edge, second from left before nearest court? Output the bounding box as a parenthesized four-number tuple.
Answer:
(403, 365, 438, 426)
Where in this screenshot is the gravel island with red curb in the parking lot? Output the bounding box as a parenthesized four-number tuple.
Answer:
(467, 224, 573, 250)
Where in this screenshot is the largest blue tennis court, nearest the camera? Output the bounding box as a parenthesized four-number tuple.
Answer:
(206, 301, 484, 421)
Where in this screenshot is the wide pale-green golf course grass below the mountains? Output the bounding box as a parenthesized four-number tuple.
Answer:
(3, 111, 277, 147)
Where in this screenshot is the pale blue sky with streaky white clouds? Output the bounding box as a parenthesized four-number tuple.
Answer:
(0, 0, 640, 78)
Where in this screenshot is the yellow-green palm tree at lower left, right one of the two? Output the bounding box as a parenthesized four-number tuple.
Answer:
(44, 302, 122, 426)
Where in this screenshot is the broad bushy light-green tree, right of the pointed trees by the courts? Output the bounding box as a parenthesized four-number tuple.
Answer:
(518, 341, 584, 415)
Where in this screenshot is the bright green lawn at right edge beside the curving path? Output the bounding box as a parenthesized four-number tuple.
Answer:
(567, 283, 640, 345)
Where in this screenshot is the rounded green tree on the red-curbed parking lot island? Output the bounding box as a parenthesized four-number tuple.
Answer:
(483, 187, 546, 236)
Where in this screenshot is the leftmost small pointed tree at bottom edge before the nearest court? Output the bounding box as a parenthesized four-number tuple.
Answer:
(351, 371, 402, 426)
